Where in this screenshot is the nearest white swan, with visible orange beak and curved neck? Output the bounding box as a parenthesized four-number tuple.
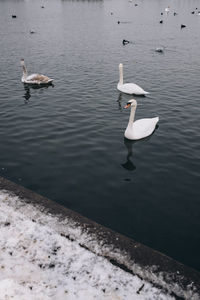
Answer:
(124, 99, 159, 140)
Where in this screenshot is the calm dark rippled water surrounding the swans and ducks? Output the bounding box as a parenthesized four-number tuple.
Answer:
(0, 0, 200, 270)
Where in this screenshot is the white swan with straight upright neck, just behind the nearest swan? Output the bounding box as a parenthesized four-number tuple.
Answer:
(117, 64, 149, 95)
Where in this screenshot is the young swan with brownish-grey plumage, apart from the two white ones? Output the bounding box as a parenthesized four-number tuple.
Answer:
(21, 59, 53, 84)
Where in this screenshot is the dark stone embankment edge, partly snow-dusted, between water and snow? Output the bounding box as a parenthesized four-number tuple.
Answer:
(0, 177, 200, 300)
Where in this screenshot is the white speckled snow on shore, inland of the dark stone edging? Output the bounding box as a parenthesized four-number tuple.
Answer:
(0, 191, 174, 300)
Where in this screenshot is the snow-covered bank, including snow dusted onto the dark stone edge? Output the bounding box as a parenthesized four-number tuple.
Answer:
(0, 177, 200, 300)
